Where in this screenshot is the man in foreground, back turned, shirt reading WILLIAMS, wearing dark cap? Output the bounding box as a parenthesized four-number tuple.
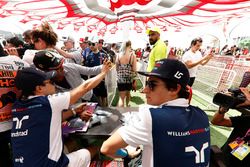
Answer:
(101, 59, 210, 167)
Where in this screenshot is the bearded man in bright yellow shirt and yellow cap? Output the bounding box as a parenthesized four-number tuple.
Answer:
(146, 27, 167, 72)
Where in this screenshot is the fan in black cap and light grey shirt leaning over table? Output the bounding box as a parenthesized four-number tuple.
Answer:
(33, 51, 103, 102)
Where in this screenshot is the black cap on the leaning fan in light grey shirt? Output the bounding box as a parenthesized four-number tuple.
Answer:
(33, 50, 64, 71)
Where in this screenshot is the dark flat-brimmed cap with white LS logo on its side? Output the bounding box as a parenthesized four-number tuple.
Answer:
(138, 59, 189, 88)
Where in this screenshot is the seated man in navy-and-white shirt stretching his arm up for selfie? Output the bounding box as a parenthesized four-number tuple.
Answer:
(11, 62, 110, 167)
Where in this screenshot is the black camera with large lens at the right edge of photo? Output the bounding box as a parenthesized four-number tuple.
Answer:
(213, 88, 246, 109)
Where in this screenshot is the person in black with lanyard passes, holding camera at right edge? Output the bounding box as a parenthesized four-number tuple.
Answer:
(211, 88, 250, 167)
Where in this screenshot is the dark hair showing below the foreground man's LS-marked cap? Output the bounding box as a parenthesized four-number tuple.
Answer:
(160, 78, 189, 99)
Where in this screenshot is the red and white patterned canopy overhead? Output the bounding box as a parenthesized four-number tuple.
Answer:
(0, 0, 250, 35)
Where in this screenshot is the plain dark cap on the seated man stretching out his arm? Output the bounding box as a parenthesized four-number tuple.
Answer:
(15, 67, 56, 92)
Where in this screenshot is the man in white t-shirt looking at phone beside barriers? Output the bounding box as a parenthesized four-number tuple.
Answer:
(182, 38, 213, 87)
